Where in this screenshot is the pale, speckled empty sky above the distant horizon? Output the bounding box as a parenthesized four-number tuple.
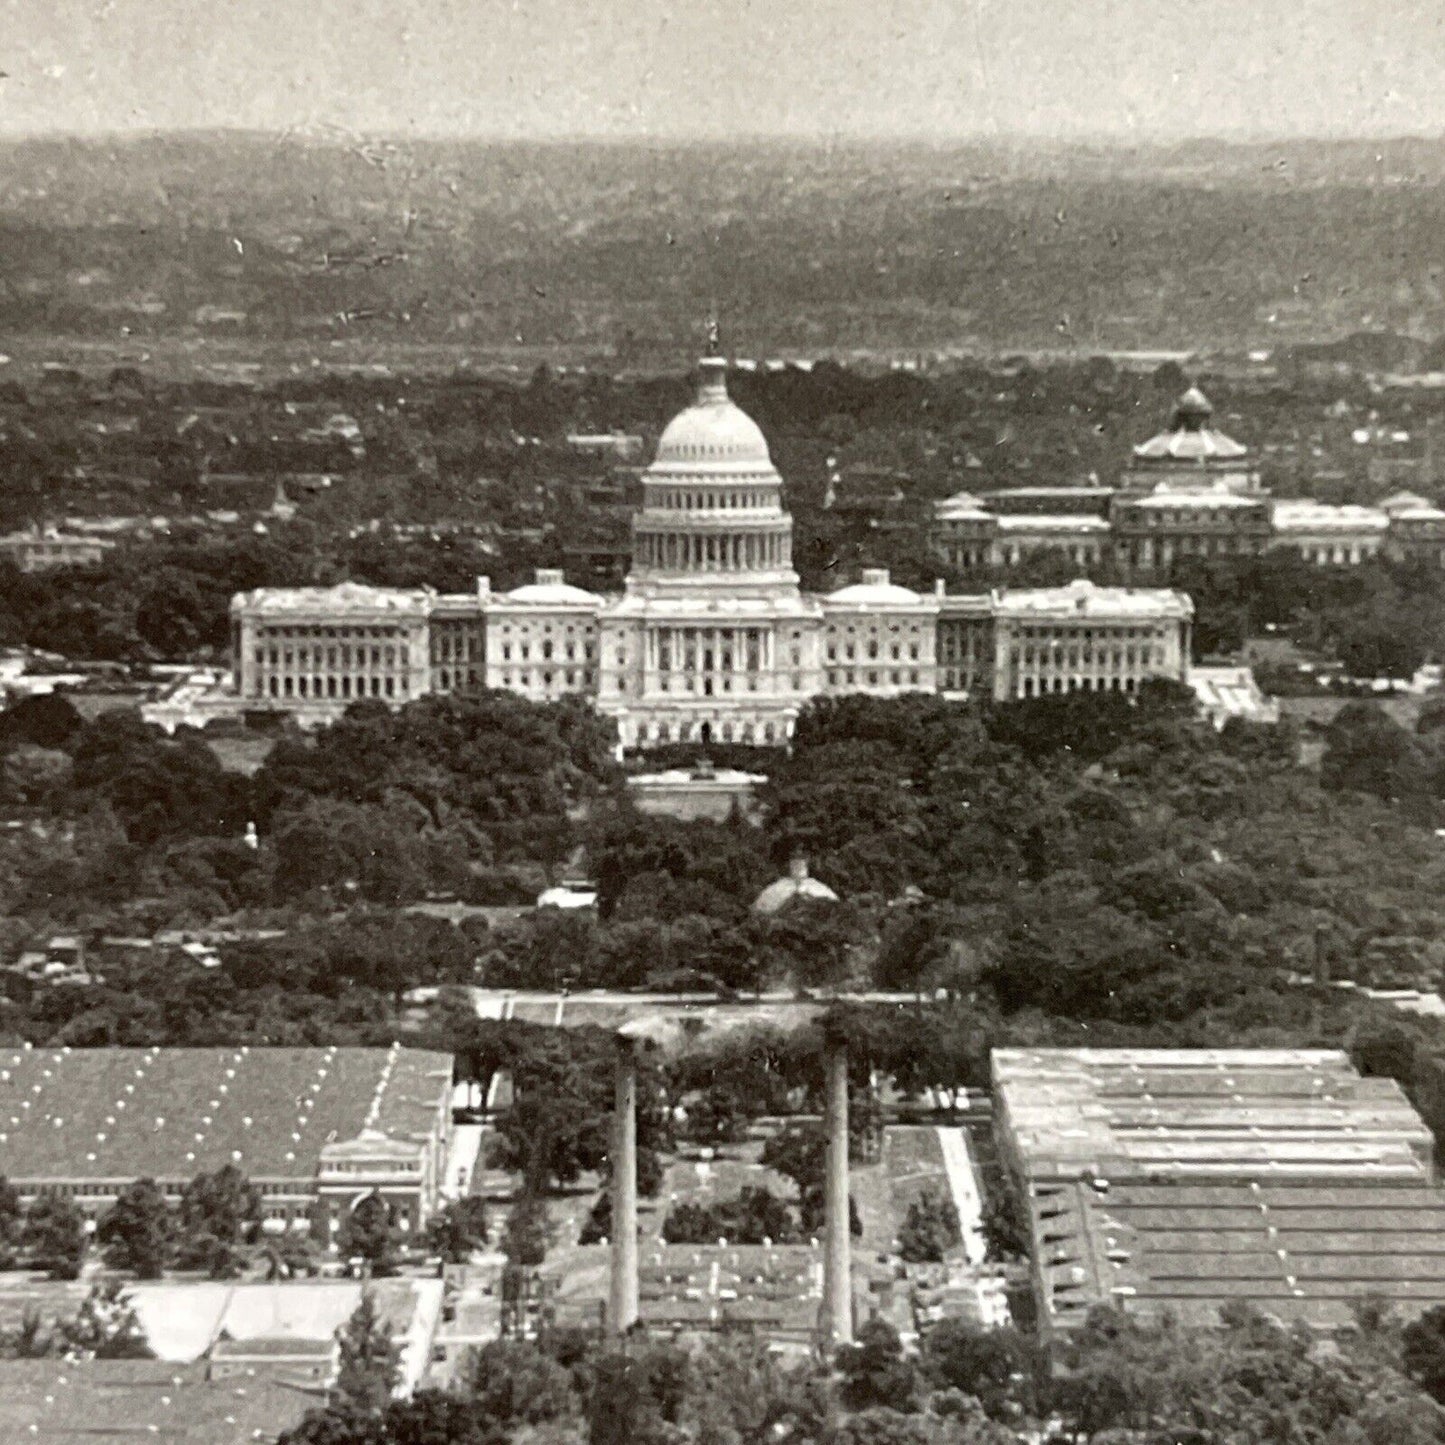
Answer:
(0, 0, 1445, 140)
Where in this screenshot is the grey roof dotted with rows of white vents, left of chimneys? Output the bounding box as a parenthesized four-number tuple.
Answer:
(0, 1045, 452, 1185)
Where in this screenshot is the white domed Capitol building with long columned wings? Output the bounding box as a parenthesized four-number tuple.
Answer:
(169, 357, 1192, 749)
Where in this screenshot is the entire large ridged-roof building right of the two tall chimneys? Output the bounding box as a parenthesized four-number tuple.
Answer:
(993, 1049, 1445, 1332)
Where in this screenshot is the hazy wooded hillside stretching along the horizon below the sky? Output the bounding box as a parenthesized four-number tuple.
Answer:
(8, 133, 1445, 355)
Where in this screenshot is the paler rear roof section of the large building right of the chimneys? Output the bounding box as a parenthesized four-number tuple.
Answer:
(993, 1049, 1435, 1185)
